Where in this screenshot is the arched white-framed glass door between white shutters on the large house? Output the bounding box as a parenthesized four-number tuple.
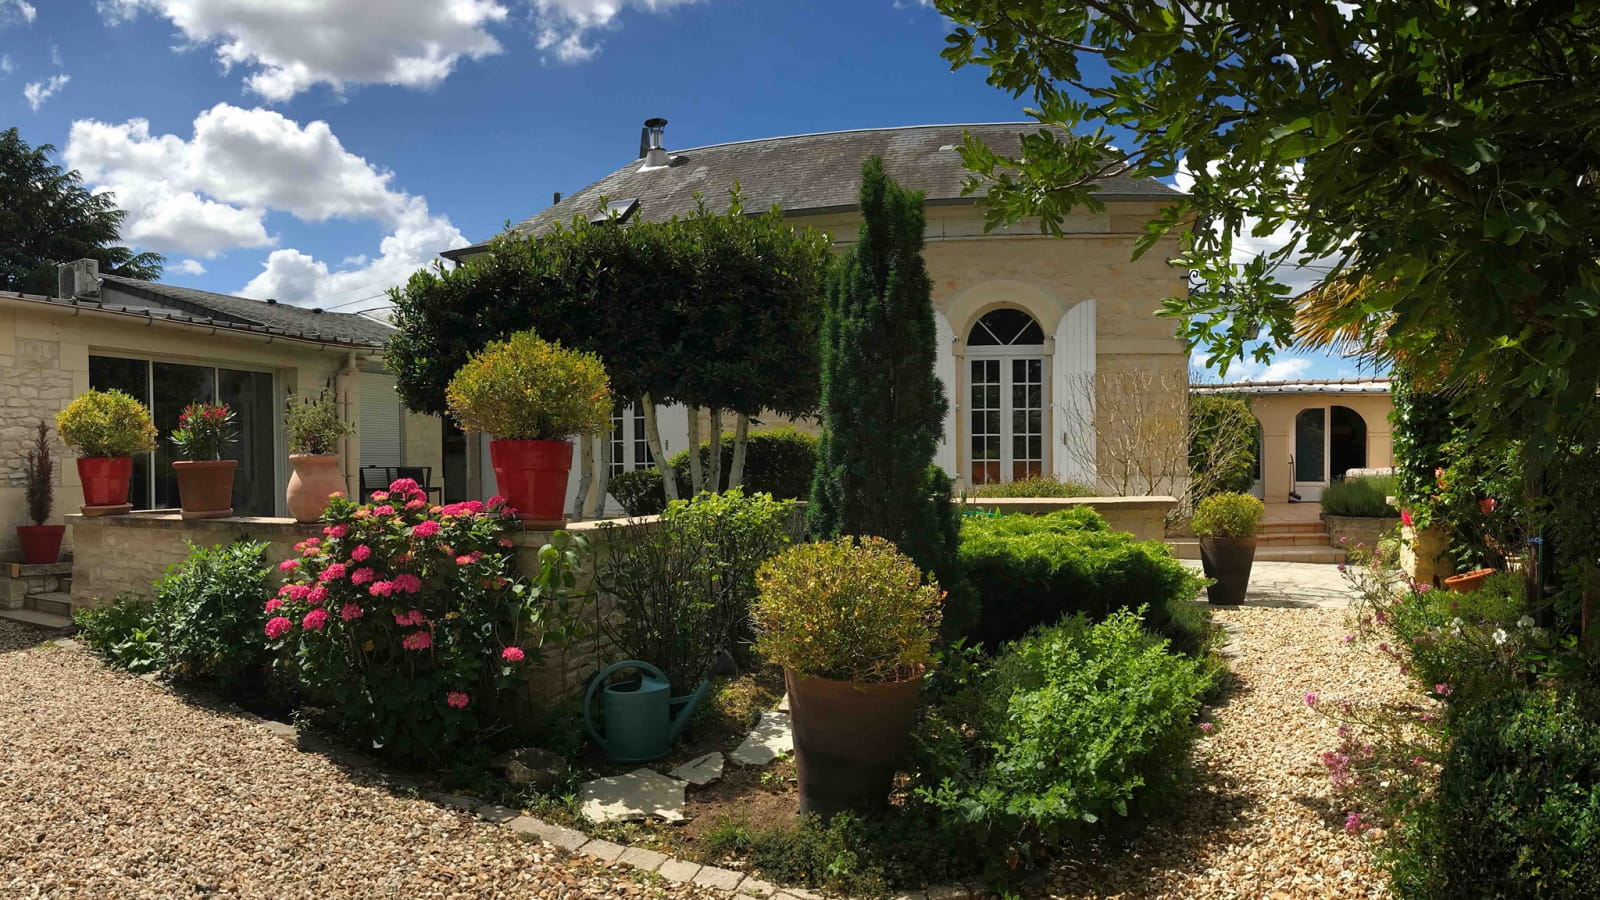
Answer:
(966, 307, 1050, 485)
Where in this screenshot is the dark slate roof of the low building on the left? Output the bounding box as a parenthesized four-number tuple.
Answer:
(96, 275, 395, 348)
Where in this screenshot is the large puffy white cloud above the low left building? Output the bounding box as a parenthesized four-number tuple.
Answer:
(66, 104, 466, 306)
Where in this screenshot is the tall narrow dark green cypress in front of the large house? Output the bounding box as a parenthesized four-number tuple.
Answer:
(808, 157, 958, 588)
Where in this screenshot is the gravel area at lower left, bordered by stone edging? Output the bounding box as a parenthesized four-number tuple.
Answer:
(0, 621, 717, 900)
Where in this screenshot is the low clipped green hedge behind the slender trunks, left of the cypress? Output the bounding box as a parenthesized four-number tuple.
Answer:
(608, 428, 816, 516)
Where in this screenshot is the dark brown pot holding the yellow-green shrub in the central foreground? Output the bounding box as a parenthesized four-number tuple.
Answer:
(784, 669, 923, 818)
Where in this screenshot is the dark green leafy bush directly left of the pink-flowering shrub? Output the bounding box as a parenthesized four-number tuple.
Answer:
(152, 541, 272, 687)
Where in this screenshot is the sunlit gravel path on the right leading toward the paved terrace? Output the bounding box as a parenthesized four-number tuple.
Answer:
(1048, 564, 1410, 900)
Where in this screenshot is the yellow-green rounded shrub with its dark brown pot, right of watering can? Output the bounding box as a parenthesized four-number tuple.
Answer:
(750, 536, 944, 818)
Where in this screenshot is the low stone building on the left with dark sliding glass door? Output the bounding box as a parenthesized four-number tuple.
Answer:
(0, 259, 442, 554)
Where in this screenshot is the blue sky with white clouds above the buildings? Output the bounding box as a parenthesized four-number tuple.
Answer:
(0, 0, 1355, 378)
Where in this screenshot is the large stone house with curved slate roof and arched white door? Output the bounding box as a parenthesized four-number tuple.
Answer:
(445, 119, 1187, 493)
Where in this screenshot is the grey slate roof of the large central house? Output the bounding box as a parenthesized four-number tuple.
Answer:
(443, 122, 1179, 259)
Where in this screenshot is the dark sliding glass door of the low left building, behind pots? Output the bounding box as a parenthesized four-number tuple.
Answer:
(90, 356, 278, 516)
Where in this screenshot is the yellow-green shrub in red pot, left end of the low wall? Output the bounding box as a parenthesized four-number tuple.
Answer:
(56, 391, 155, 516)
